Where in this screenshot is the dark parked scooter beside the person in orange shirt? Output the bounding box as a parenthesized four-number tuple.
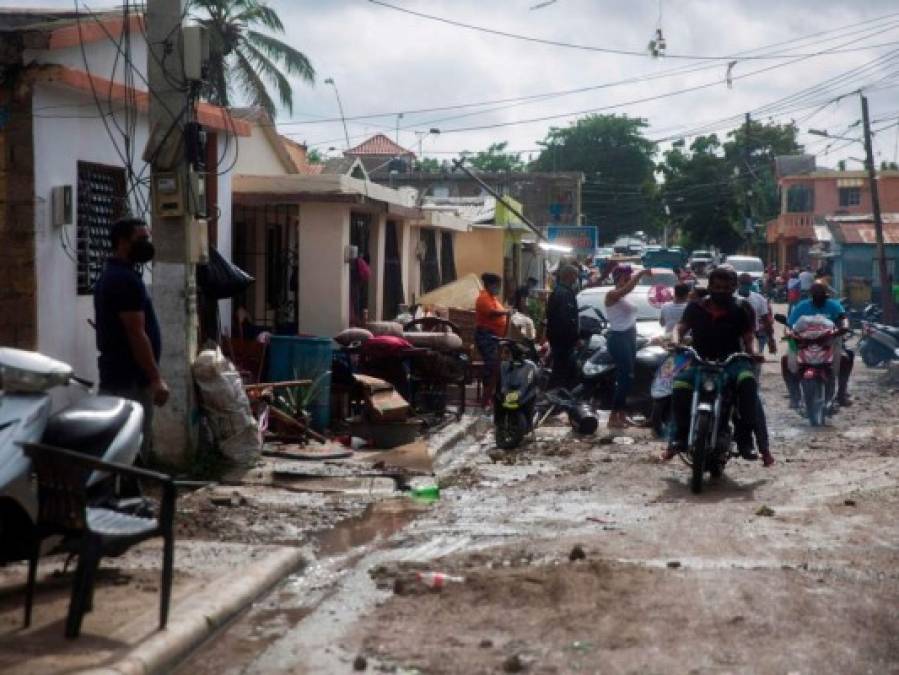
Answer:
(493, 338, 539, 450)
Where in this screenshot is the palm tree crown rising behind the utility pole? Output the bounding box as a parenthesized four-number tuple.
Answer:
(189, 0, 315, 118)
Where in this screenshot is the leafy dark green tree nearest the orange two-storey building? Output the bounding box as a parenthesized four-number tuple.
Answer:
(658, 122, 802, 251)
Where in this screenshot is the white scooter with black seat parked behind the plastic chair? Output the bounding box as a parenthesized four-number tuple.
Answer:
(0, 347, 144, 563)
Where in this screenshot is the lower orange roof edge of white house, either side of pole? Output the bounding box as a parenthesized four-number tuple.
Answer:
(28, 65, 250, 136)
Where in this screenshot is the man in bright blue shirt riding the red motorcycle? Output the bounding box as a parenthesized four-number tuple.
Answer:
(781, 280, 855, 409)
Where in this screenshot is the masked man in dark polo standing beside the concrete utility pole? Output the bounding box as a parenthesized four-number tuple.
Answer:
(94, 218, 169, 462)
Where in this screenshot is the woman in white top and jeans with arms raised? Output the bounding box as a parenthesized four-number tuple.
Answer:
(605, 265, 652, 429)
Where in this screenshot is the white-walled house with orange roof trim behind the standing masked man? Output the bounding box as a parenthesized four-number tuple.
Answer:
(0, 9, 249, 379)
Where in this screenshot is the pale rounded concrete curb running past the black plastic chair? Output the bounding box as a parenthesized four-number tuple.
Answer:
(79, 547, 304, 675)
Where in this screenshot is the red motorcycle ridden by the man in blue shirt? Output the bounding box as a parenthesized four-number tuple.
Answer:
(786, 316, 846, 427)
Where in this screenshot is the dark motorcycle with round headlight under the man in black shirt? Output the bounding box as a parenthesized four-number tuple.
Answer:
(677, 347, 752, 494)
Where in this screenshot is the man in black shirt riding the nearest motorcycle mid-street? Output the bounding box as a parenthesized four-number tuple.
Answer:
(662, 267, 774, 466)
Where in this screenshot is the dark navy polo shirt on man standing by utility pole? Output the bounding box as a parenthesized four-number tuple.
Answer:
(94, 258, 162, 389)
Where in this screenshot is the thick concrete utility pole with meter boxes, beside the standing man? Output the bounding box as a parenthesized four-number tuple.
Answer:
(146, 0, 199, 466)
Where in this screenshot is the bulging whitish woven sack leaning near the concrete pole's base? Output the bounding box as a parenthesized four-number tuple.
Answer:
(191, 348, 262, 466)
